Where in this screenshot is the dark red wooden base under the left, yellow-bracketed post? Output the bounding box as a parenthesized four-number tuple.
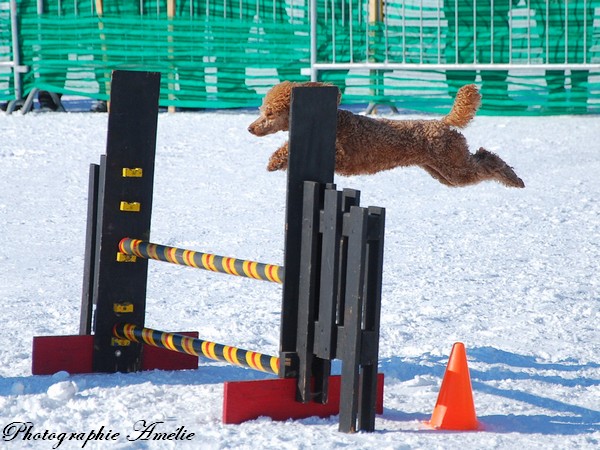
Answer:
(31, 332, 198, 375)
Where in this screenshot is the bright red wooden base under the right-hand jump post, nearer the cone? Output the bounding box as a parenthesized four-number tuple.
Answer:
(223, 373, 384, 424)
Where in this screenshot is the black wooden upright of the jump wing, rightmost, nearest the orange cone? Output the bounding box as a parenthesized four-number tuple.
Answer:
(337, 206, 385, 433)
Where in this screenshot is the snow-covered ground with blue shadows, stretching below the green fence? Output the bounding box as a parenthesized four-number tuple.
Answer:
(0, 103, 600, 449)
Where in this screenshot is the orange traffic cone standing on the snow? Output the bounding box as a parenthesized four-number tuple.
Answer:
(427, 342, 478, 430)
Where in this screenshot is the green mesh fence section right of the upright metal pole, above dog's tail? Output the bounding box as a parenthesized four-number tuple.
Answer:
(317, 0, 600, 115)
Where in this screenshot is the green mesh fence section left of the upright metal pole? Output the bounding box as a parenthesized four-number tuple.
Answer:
(19, 0, 309, 108)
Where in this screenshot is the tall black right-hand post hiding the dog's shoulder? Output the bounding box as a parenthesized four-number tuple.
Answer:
(279, 86, 338, 378)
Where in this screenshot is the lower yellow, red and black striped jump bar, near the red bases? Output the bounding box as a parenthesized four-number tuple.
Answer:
(113, 323, 279, 375)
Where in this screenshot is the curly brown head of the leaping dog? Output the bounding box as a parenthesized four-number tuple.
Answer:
(248, 81, 341, 136)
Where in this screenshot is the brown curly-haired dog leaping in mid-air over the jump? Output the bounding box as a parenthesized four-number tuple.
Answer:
(248, 81, 525, 188)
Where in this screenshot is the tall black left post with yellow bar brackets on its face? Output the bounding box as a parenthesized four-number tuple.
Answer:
(93, 71, 160, 372)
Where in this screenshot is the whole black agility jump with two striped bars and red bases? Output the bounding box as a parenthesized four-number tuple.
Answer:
(32, 71, 385, 432)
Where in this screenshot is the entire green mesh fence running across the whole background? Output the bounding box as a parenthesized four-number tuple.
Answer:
(0, 0, 600, 114)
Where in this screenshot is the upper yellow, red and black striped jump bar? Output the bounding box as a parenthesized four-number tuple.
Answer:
(117, 238, 284, 284)
